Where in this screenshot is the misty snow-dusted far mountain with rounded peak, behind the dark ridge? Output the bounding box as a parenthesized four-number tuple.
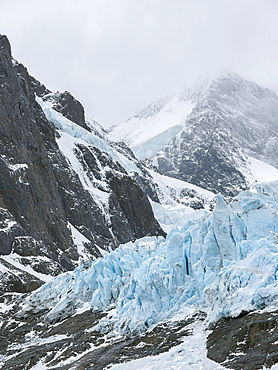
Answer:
(110, 71, 278, 196)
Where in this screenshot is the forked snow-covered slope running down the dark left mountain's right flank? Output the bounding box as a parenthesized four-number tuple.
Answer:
(37, 98, 215, 232)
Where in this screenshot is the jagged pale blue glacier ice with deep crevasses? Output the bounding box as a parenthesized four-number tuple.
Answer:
(23, 182, 278, 332)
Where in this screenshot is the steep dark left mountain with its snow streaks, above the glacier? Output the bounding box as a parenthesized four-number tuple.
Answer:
(0, 36, 165, 292)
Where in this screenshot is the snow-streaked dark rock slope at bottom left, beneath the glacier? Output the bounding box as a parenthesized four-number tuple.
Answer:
(0, 295, 204, 370)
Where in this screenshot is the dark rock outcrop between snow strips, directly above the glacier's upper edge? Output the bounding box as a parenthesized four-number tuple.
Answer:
(68, 144, 165, 249)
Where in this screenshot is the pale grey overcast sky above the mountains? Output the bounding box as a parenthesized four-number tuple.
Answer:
(0, 0, 278, 127)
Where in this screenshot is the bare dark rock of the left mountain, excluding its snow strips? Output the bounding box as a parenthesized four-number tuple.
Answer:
(0, 36, 163, 290)
